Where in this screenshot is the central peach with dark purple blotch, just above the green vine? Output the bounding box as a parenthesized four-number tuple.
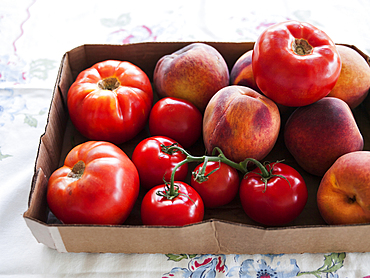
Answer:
(203, 85, 280, 162)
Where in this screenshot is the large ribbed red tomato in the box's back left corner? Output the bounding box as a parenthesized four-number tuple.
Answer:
(67, 60, 153, 144)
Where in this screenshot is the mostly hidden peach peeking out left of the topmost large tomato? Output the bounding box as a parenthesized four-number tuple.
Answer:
(230, 50, 260, 93)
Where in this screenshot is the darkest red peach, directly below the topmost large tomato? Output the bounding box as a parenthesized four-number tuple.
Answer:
(284, 97, 364, 176)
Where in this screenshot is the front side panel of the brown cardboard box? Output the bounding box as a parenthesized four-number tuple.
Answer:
(22, 217, 370, 254)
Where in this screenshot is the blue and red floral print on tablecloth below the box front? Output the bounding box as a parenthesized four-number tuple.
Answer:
(162, 253, 350, 278)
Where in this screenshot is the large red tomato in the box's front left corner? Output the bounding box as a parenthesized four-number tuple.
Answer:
(47, 141, 140, 225)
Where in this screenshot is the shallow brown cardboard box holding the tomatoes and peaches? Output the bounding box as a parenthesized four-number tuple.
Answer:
(24, 42, 370, 254)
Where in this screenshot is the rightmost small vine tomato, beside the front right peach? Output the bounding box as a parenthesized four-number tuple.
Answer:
(239, 163, 308, 226)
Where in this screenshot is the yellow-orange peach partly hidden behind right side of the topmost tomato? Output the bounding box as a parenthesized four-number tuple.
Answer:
(328, 45, 370, 109)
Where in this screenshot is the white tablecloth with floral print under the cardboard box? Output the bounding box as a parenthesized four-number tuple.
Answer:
(0, 0, 370, 277)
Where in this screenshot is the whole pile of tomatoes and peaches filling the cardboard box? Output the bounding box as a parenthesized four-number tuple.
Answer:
(47, 21, 370, 226)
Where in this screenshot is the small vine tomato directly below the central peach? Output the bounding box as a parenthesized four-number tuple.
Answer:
(190, 161, 240, 208)
